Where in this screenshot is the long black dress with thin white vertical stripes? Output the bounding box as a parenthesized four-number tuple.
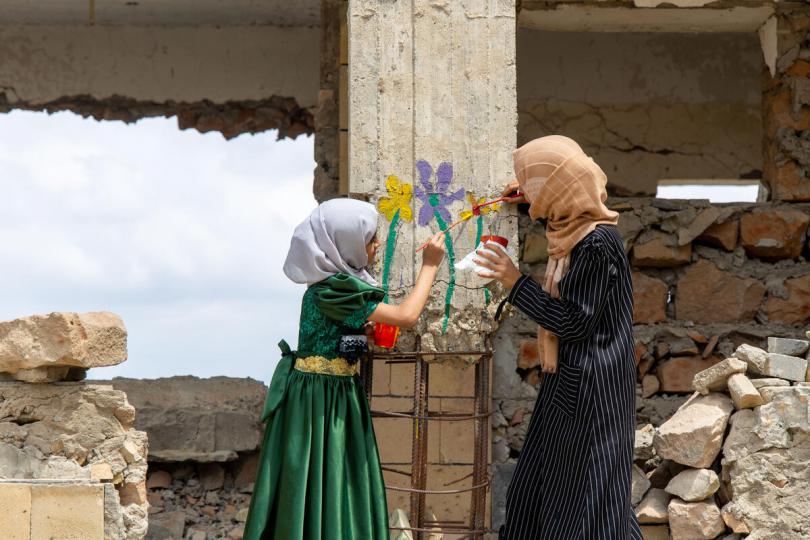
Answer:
(500, 225, 642, 540)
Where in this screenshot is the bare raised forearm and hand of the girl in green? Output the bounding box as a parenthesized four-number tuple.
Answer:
(368, 233, 444, 328)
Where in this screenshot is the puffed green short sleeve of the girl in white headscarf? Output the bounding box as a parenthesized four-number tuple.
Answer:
(312, 274, 385, 328)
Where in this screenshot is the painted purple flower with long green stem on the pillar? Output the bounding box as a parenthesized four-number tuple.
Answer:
(414, 159, 464, 333)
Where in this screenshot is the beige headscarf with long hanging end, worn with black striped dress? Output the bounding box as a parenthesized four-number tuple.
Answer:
(513, 135, 619, 373)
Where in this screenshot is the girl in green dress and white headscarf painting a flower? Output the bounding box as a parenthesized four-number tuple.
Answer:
(244, 199, 444, 540)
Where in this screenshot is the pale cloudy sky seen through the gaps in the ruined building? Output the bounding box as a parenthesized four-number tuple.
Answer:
(0, 111, 756, 381)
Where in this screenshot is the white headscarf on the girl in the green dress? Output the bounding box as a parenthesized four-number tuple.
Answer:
(284, 199, 378, 285)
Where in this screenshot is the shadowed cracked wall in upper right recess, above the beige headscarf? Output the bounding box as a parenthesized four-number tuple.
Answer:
(517, 28, 763, 195)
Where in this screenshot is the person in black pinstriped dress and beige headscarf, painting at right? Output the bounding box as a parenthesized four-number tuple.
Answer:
(479, 136, 642, 540)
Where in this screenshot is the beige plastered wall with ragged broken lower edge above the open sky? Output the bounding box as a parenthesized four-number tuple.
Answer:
(0, 25, 319, 137)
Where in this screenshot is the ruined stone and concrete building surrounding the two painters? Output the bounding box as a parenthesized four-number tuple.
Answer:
(0, 0, 810, 540)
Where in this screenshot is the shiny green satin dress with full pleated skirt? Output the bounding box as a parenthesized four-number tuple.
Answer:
(243, 274, 388, 540)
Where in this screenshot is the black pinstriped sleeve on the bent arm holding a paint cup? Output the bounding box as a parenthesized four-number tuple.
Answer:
(508, 240, 617, 341)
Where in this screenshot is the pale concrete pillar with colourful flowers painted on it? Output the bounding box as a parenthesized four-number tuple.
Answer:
(348, 0, 517, 351)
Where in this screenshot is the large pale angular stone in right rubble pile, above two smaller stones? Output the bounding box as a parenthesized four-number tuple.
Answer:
(653, 393, 734, 468)
